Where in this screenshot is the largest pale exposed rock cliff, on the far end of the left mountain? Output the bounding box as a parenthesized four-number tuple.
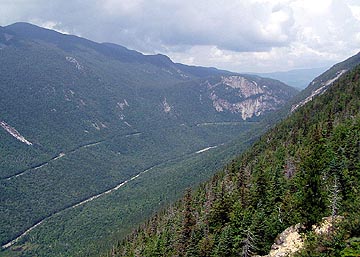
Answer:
(207, 76, 285, 120)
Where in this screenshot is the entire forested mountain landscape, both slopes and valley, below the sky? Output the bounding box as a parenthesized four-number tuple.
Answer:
(0, 23, 360, 256)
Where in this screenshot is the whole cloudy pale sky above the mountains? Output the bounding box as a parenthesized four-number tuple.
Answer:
(0, 0, 360, 72)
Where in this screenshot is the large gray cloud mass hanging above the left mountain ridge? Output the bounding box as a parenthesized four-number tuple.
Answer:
(3, 0, 294, 52)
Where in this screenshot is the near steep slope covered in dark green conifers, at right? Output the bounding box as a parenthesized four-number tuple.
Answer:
(114, 65, 360, 256)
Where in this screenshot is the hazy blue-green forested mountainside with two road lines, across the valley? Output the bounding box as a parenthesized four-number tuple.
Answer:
(0, 23, 296, 256)
